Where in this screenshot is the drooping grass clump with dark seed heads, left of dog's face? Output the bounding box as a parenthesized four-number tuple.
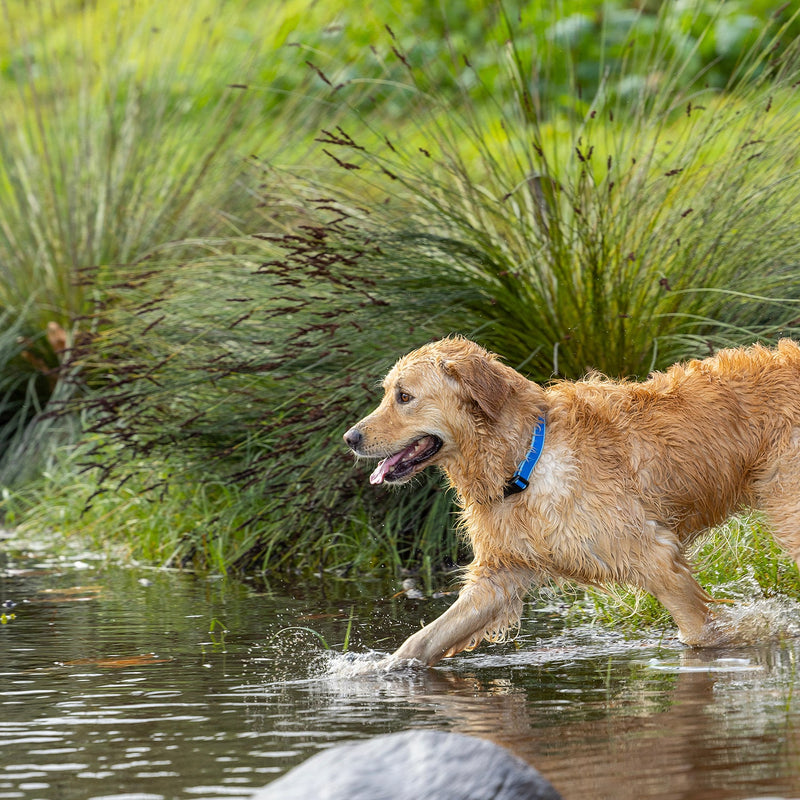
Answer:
(56, 229, 466, 570)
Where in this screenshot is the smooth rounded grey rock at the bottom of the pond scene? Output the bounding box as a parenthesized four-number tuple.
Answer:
(253, 730, 561, 800)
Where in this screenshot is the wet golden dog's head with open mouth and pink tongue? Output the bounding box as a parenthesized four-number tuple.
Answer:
(344, 337, 527, 484)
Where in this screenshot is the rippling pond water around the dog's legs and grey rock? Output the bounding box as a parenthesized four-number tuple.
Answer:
(0, 536, 800, 800)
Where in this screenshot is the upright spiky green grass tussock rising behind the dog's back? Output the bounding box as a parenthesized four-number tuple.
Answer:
(302, 7, 798, 379)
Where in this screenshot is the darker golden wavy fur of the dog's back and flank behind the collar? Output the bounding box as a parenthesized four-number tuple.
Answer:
(548, 339, 800, 542)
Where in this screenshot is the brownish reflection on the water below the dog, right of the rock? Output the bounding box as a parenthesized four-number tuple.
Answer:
(312, 637, 800, 799)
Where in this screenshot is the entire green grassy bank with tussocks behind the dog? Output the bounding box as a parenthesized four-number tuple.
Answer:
(0, 0, 800, 636)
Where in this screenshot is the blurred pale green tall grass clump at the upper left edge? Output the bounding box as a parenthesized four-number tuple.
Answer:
(0, 0, 340, 485)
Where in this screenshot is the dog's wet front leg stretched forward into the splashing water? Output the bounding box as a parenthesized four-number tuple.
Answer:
(392, 565, 531, 666)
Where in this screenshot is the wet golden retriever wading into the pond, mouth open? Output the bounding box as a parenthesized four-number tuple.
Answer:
(344, 337, 800, 665)
